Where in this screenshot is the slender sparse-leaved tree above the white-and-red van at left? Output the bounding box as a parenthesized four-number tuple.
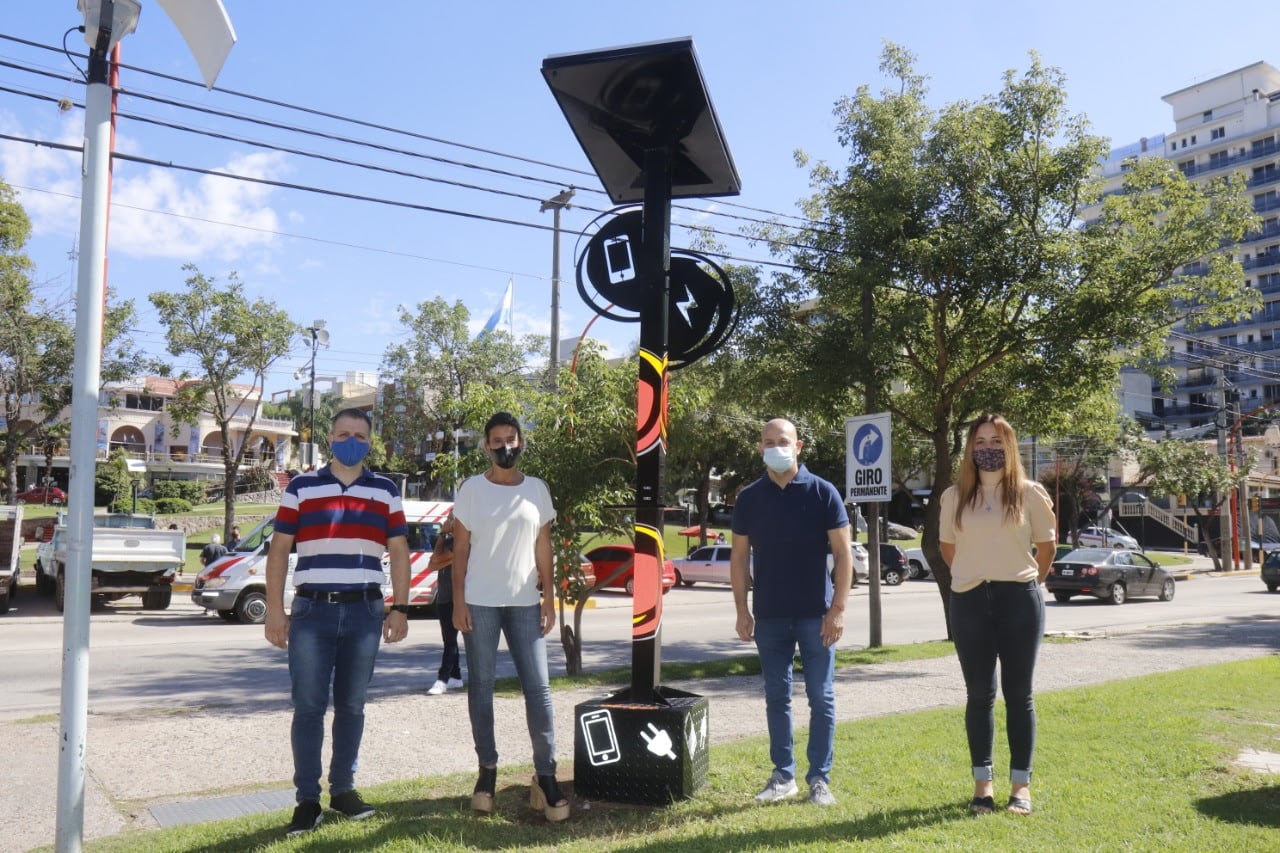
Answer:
(150, 264, 300, 537)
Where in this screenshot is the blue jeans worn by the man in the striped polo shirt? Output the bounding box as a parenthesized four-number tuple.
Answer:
(289, 596, 385, 803)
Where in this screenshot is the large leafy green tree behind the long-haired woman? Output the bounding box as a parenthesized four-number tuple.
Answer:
(752, 45, 1258, 630)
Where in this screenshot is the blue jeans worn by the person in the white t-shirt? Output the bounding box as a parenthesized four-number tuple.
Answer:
(462, 605, 556, 776)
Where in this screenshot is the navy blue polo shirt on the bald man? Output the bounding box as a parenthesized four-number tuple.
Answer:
(733, 465, 849, 619)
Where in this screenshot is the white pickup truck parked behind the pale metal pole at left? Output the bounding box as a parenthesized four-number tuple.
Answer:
(36, 515, 187, 611)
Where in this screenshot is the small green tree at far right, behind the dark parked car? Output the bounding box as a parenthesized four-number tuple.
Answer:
(1138, 441, 1256, 571)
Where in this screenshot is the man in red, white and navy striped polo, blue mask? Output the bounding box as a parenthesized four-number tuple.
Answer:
(266, 409, 410, 835)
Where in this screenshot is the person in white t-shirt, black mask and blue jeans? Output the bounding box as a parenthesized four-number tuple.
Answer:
(453, 411, 568, 821)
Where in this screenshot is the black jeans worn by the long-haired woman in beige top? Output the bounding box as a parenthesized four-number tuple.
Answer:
(951, 580, 1044, 783)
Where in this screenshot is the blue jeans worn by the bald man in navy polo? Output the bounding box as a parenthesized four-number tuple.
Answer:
(755, 616, 836, 784)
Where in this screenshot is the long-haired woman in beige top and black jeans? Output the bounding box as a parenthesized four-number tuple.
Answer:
(938, 415, 1057, 815)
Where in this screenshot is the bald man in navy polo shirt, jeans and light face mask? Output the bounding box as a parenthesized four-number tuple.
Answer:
(730, 418, 854, 806)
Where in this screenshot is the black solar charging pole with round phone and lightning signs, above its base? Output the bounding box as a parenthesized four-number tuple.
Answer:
(543, 38, 741, 702)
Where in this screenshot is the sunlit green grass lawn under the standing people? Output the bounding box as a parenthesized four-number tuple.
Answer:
(87, 657, 1280, 853)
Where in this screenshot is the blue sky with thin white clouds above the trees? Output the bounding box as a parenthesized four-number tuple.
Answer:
(0, 0, 1280, 392)
